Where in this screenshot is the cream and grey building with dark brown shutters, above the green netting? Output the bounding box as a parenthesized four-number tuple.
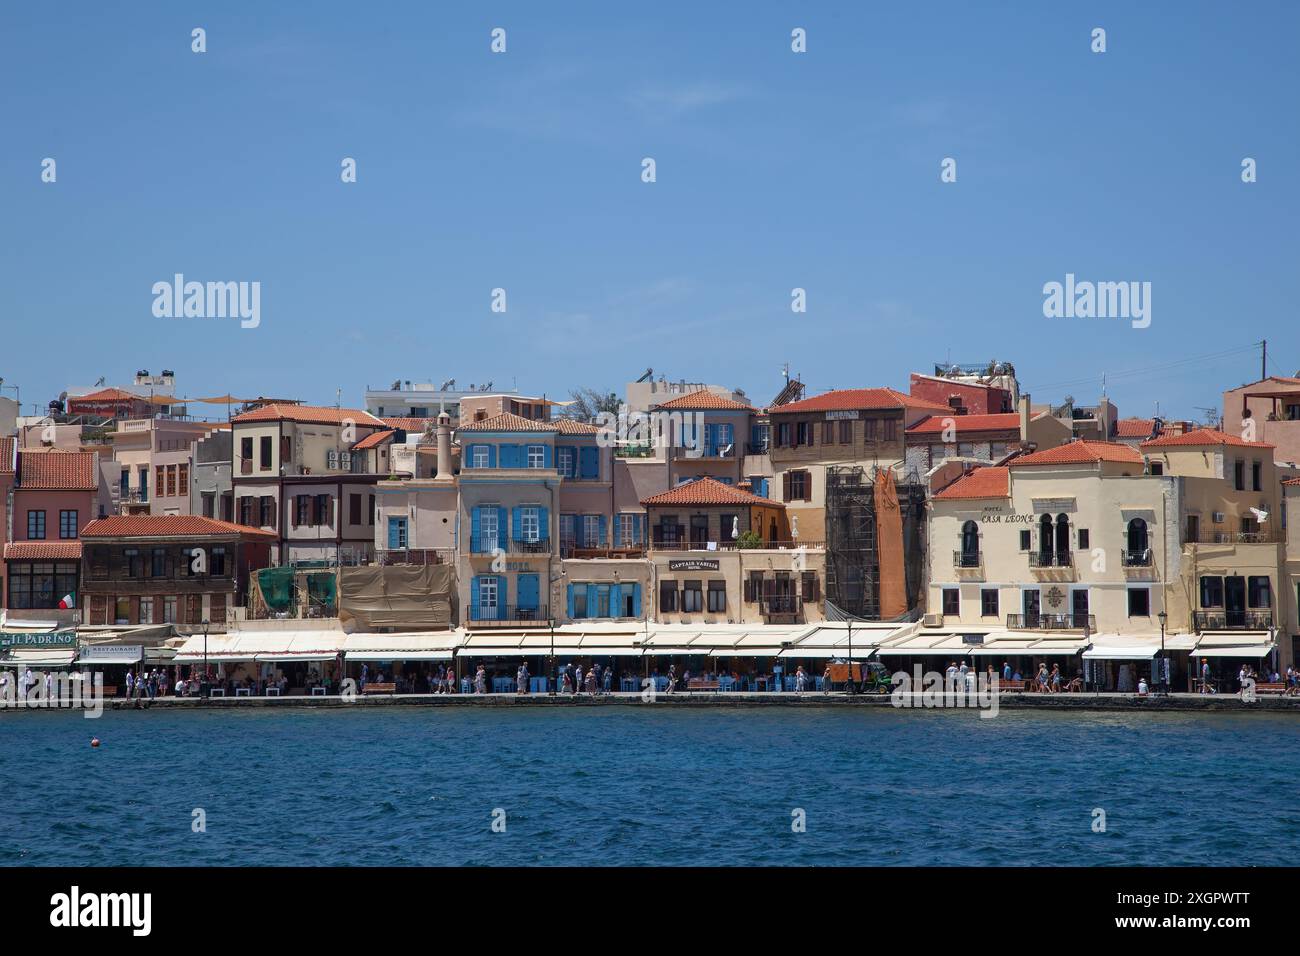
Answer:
(231, 403, 386, 564)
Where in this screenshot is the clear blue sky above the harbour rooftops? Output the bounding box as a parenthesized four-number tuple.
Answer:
(0, 0, 1300, 416)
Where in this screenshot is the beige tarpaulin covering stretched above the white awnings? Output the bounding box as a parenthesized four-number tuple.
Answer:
(338, 564, 454, 631)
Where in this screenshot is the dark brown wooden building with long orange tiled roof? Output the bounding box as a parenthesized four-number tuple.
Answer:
(81, 515, 277, 633)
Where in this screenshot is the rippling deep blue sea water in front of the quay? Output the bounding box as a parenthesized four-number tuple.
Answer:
(0, 705, 1300, 866)
